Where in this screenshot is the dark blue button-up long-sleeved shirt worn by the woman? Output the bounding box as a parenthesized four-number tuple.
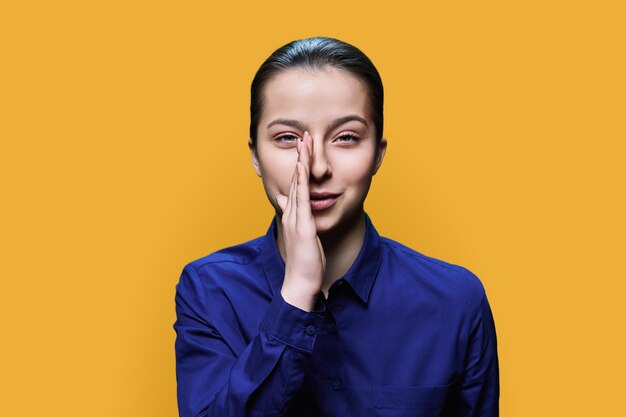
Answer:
(174, 215, 499, 417)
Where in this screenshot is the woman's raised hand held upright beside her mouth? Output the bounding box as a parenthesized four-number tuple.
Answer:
(276, 132, 326, 311)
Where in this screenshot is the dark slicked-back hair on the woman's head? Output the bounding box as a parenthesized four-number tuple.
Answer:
(250, 37, 384, 147)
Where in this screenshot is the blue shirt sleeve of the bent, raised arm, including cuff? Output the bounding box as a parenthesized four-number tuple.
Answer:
(174, 265, 324, 417)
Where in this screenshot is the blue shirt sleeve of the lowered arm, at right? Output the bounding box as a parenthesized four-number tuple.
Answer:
(457, 285, 500, 417)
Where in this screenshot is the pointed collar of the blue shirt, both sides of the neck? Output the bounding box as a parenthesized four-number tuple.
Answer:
(261, 213, 382, 303)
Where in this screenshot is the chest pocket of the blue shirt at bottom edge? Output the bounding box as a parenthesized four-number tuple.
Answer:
(372, 381, 455, 417)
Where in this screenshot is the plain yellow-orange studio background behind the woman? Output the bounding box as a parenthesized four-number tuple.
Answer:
(0, 1, 626, 417)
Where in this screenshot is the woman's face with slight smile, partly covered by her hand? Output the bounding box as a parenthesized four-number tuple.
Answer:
(252, 67, 386, 235)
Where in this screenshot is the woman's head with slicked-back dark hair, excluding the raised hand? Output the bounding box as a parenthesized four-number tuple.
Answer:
(249, 38, 387, 235)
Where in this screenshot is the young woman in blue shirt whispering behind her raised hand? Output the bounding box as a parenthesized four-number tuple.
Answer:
(174, 38, 499, 417)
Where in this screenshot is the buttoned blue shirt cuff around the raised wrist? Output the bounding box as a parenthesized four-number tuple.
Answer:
(262, 292, 326, 352)
